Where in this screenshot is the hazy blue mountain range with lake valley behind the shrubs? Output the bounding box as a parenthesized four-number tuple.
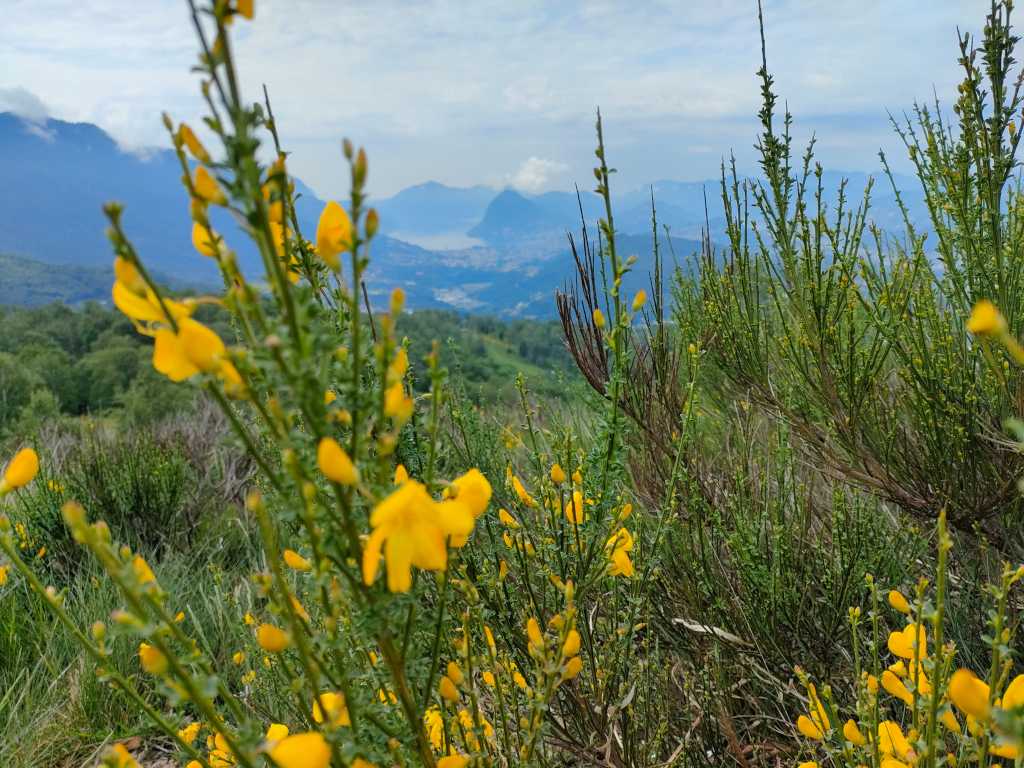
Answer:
(0, 113, 925, 316)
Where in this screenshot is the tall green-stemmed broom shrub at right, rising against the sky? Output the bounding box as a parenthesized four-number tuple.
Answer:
(693, 2, 1024, 551)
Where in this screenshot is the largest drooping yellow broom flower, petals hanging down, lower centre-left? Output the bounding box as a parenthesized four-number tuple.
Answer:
(362, 480, 473, 592)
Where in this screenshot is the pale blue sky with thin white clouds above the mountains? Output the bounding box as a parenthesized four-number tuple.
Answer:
(0, 0, 989, 198)
